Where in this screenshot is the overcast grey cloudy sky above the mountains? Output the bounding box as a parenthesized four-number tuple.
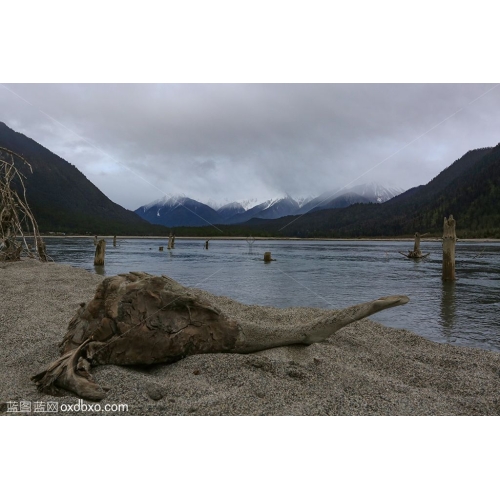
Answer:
(0, 83, 500, 210)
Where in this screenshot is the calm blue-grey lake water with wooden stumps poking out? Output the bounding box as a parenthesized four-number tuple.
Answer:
(46, 238, 500, 351)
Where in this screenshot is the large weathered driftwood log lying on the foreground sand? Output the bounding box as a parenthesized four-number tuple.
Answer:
(32, 273, 409, 400)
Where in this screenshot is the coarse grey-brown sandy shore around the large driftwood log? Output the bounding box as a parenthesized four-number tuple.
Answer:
(0, 260, 500, 415)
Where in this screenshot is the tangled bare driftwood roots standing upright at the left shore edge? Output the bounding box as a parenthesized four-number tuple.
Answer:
(0, 147, 47, 261)
